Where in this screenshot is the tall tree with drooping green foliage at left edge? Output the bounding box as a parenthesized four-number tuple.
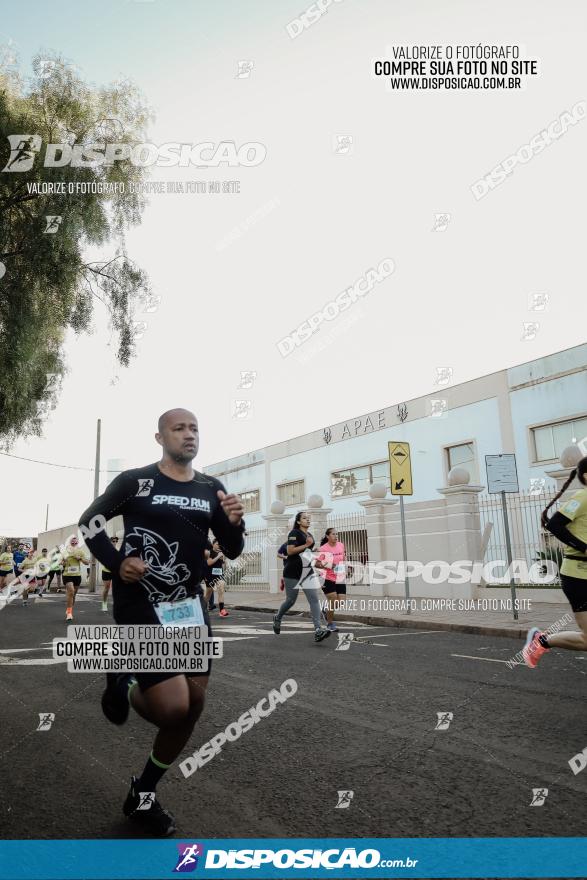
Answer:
(0, 52, 151, 445)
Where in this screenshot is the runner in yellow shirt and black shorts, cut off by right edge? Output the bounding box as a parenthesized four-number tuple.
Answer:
(522, 456, 587, 669)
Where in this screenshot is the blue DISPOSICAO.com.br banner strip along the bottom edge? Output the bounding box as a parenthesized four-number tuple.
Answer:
(0, 837, 587, 880)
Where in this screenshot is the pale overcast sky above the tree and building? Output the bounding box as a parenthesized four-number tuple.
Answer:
(0, 0, 587, 535)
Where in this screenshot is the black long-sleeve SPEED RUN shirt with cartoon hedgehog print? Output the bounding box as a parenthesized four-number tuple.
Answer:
(79, 464, 244, 619)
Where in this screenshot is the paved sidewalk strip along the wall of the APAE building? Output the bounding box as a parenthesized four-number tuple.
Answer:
(225, 590, 577, 639)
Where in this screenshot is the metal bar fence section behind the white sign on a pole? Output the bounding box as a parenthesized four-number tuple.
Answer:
(479, 491, 560, 587)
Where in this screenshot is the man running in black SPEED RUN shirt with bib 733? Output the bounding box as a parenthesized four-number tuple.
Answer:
(79, 409, 244, 836)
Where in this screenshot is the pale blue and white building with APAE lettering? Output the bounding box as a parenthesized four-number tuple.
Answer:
(204, 344, 587, 529)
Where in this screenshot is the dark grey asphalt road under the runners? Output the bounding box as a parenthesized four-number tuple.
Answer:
(0, 595, 587, 852)
